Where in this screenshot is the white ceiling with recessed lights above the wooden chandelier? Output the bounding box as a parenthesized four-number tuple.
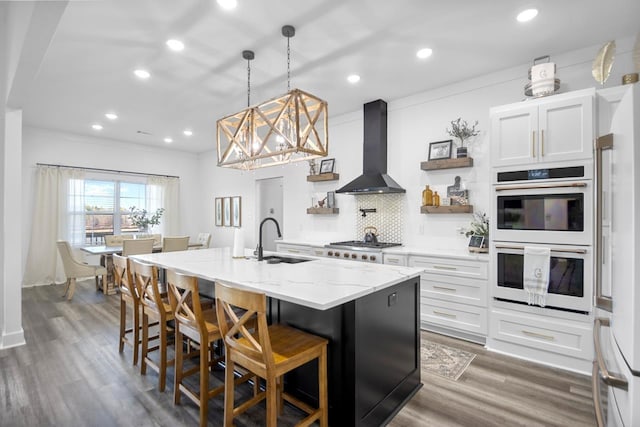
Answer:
(23, 0, 640, 152)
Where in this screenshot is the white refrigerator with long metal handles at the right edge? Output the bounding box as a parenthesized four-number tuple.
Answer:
(593, 84, 640, 427)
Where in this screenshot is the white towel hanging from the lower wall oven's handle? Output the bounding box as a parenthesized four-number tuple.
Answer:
(522, 246, 551, 307)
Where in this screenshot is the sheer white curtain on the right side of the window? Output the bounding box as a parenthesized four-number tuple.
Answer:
(147, 176, 181, 236)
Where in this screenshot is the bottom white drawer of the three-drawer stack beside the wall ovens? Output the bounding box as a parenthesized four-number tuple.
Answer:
(420, 297, 487, 335)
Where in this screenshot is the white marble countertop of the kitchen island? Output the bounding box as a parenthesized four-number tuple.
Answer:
(132, 248, 422, 310)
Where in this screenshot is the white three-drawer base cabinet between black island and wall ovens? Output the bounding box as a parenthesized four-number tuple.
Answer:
(408, 255, 488, 343)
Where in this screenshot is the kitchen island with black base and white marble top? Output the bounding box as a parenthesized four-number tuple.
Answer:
(134, 248, 422, 426)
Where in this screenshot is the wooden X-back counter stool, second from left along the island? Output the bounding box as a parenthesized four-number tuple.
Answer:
(129, 258, 174, 391)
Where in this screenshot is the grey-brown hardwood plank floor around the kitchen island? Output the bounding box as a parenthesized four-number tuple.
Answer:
(0, 280, 595, 427)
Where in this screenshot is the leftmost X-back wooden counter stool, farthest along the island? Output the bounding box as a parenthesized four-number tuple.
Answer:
(113, 254, 141, 365)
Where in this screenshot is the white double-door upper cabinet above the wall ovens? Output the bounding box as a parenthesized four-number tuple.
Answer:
(490, 89, 595, 167)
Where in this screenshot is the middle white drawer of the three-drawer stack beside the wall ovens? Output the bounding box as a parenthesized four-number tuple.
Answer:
(420, 273, 488, 308)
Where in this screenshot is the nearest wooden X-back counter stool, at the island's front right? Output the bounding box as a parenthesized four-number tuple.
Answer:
(215, 282, 329, 427)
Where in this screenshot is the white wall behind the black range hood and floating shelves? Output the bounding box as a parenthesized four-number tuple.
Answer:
(200, 37, 634, 252)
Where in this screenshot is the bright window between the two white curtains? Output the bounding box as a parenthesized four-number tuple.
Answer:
(84, 179, 147, 244)
